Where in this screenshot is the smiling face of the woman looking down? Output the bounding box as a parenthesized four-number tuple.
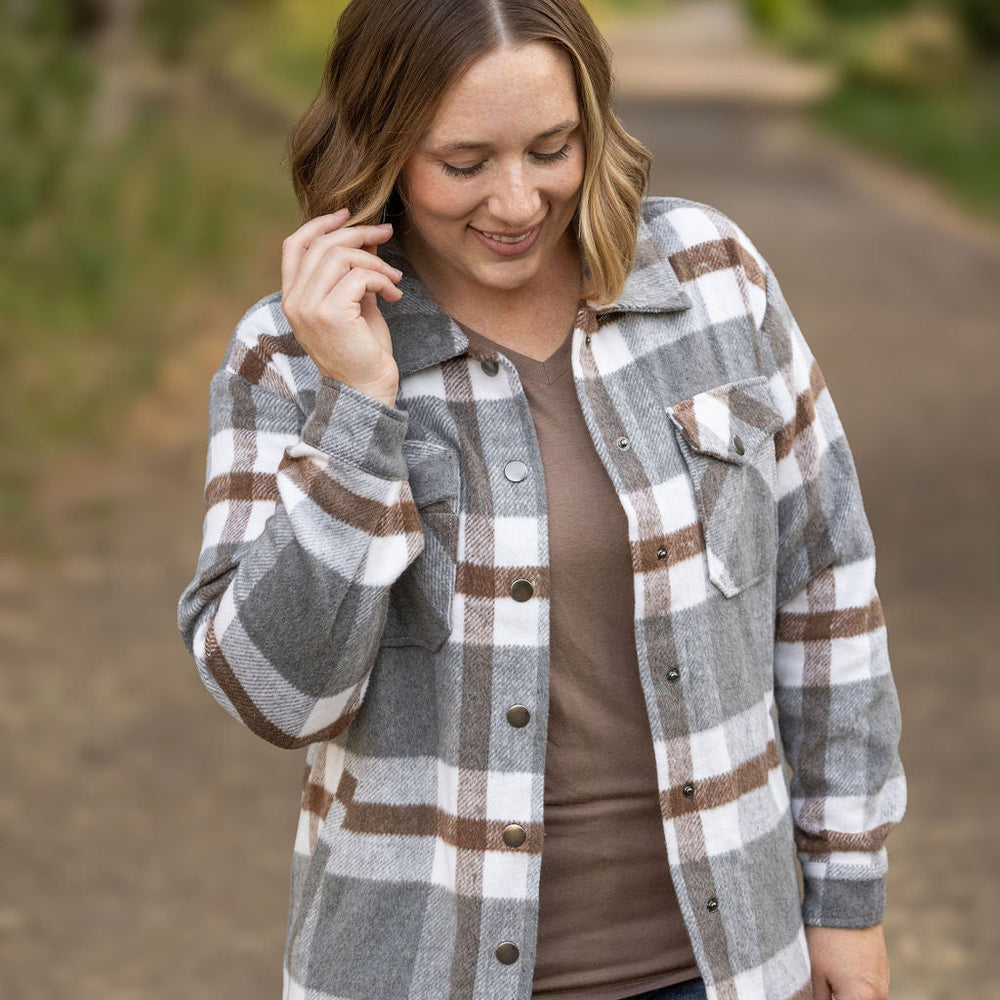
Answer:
(400, 42, 586, 295)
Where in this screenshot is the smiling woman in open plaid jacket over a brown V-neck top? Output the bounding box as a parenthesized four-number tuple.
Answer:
(180, 0, 905, 1000)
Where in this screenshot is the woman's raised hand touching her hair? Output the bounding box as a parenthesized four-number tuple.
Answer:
(281, 209, 403, 406)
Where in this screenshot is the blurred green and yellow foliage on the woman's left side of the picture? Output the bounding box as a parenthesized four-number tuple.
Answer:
(0, 0, 339, 524)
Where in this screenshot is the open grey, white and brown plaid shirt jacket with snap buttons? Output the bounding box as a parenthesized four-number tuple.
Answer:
(180, 198, 905, 1000)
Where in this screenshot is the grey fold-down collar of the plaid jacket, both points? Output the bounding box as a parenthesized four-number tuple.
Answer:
(379, 213, 693, 375)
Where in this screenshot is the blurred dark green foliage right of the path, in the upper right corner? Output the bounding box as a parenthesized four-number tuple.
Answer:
(741, 0, 1000, 220)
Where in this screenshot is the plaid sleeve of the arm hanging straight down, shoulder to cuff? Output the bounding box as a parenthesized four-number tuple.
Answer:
(758, 258, 906, 927)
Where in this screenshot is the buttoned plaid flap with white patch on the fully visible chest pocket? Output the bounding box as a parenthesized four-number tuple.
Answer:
(667, 375, 784, 465)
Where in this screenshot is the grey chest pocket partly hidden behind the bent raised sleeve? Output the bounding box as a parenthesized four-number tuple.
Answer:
(382, 441, 460, 650)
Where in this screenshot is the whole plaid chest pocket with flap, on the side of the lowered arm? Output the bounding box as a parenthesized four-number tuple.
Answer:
(668, 375, 784, 597)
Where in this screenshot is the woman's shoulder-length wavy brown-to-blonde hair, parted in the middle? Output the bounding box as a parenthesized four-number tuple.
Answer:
(288, 0, 652, 304)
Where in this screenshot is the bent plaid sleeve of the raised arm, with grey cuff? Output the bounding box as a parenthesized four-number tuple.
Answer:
(178, 305, 423, 748)
